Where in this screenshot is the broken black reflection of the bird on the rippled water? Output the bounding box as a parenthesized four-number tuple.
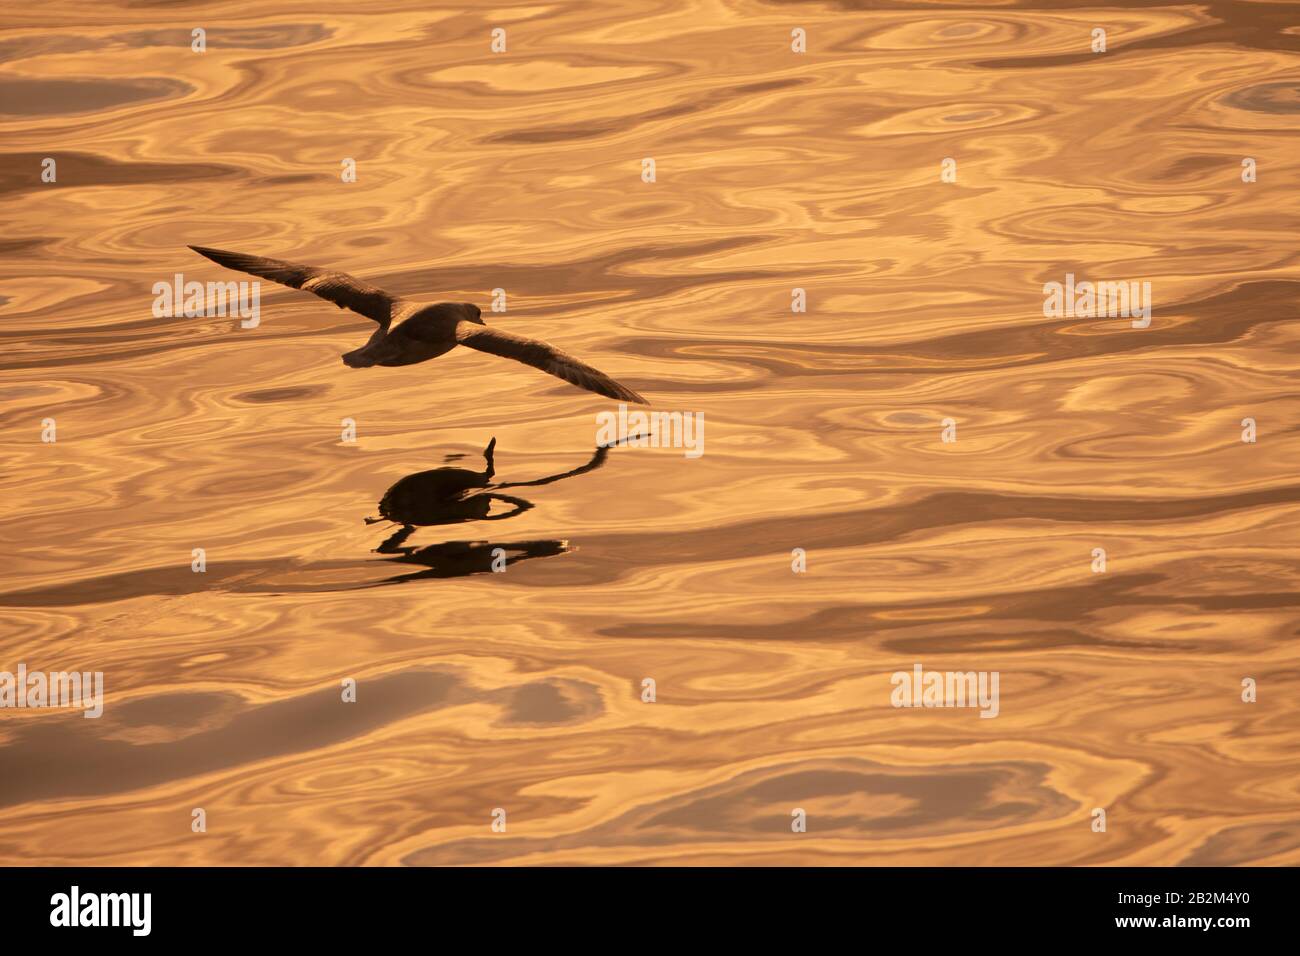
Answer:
(365, 438, 631, 583)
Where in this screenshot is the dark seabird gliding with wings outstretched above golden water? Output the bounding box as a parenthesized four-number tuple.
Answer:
(190, 246, 649, 405)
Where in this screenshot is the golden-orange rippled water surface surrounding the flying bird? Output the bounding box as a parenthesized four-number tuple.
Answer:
(0, 0, 1300, 865)
